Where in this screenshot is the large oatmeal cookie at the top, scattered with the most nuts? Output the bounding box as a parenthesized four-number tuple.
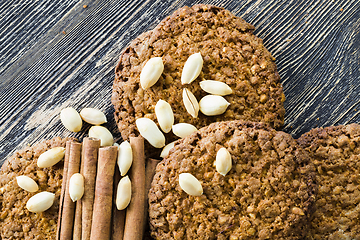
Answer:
(112, 4, 285, 158)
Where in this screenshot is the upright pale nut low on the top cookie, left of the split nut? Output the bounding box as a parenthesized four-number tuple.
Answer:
(155, 99, 174, 133)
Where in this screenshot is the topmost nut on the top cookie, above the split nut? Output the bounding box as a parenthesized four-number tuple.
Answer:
(181, 53, 203, 84)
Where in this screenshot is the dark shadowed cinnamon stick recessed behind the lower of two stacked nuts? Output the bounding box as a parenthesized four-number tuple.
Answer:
(111, 167, 126, 240)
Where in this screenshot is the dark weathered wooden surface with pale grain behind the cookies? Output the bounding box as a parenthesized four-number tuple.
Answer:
(0, 0, 360, 164)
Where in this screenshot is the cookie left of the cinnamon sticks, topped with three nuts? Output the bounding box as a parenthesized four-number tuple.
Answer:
(0, 137, 75, 240)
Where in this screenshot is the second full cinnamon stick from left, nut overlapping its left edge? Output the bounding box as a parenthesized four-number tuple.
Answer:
(81, 137, 100, 240)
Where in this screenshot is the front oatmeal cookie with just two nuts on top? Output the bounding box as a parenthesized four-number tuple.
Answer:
(149, 120, 315, 239)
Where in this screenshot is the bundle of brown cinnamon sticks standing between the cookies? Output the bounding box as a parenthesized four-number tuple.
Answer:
(56, 136, 159, 240)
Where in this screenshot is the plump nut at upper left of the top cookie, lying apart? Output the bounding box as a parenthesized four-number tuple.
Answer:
(140, 57, 164, 90)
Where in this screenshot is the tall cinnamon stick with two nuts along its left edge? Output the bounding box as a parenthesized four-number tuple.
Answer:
(124, 136, 146, 240)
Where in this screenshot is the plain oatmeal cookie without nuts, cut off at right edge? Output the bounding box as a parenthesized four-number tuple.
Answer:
(297, 124, 360, 239)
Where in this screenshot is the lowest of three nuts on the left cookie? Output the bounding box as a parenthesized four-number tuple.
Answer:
(26, 192, 55, 213)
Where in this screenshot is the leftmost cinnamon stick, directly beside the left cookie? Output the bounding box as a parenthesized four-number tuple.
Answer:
(59, 142, 82, 240)
